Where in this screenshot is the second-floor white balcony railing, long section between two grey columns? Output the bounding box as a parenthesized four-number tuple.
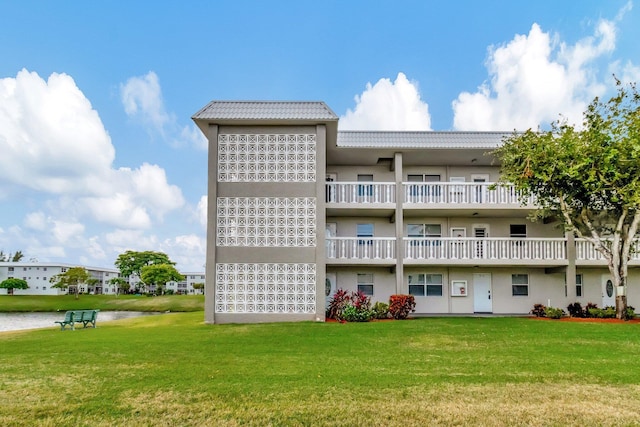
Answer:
(403, 237, 566, 260)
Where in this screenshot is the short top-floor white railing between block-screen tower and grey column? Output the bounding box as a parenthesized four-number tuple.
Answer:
(326, 182, 396, 203)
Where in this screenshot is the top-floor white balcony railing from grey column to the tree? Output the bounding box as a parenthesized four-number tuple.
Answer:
(402, 182, 533, 205)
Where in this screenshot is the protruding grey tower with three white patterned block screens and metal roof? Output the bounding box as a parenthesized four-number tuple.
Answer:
(193, 101, 338, 323)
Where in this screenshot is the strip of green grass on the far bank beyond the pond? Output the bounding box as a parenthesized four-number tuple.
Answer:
(0, 295, 204, 312)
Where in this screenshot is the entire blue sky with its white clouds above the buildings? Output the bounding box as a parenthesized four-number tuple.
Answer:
(0, 0, 640, 271)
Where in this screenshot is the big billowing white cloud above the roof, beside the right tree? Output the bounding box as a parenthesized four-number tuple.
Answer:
(453, 20, 616, 131)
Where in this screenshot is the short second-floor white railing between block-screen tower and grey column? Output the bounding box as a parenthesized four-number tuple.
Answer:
(326, 237, 396, 260)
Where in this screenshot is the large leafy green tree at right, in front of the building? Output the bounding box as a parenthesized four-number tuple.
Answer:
(495, 81, 640, 318)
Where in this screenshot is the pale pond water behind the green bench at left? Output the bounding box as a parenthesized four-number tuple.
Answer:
(0, 311, 160, 332)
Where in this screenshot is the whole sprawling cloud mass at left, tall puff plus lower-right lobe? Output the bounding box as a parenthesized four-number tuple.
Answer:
(0, 70, 184, 231)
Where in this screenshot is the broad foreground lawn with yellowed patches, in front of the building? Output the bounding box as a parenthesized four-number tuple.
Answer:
(0, 312, 640, 426)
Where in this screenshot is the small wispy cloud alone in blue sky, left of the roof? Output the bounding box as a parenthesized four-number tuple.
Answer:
(120, 71, 174, 133)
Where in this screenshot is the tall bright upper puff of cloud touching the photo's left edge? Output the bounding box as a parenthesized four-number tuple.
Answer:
(0, 70, 115, 194)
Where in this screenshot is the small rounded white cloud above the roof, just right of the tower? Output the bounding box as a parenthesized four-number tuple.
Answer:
(339, 73, 431, 130)
